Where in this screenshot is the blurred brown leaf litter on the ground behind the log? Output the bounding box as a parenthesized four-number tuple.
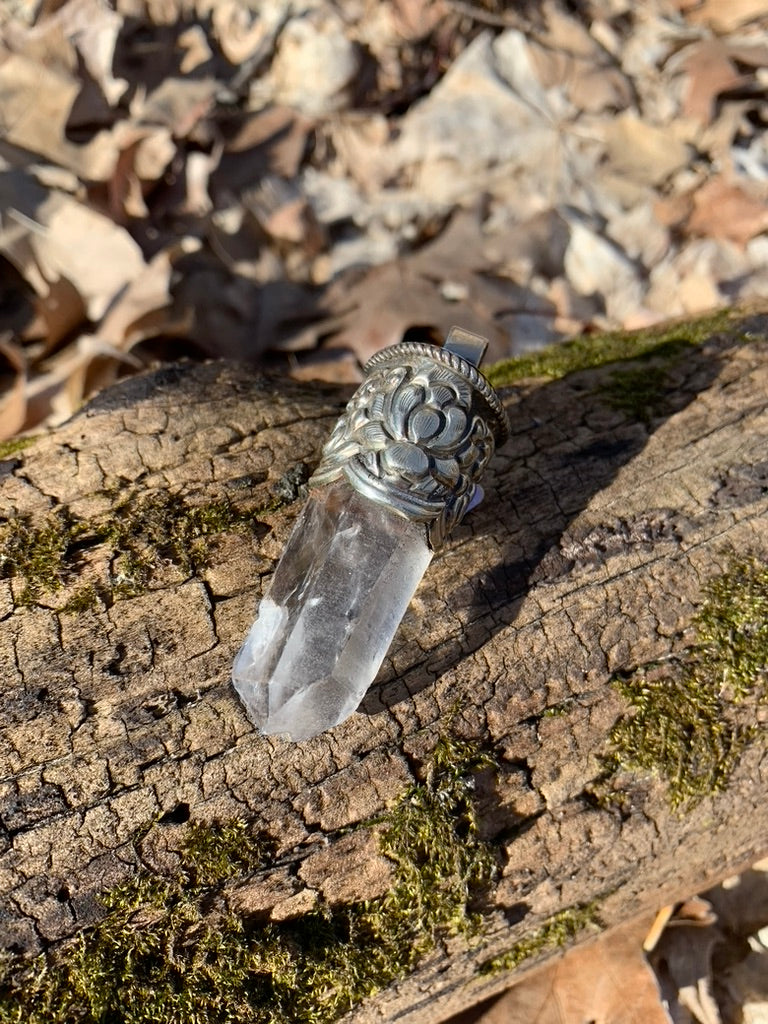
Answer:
(0, 0, 768, 437)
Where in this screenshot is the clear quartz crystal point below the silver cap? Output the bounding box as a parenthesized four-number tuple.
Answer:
(232, 479, 432, 739)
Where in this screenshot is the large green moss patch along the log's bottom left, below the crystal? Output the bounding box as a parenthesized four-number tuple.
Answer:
(0, 740, 495, 1024)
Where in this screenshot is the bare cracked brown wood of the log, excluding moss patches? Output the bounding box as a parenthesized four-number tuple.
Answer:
(0, 317, 768, 1024)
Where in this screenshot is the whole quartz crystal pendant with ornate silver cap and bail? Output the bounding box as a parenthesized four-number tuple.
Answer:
(232, 328, 508, 739)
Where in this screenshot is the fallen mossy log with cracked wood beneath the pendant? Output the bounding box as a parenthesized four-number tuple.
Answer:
(0, 313, 768, 1024)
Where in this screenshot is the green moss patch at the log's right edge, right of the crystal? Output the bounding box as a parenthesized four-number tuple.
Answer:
(597, 556, 768, 807)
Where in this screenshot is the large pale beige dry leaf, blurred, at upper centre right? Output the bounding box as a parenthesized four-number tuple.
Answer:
(391, 30, 594, 206)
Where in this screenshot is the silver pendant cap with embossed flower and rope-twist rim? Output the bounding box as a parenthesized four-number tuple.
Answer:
(310, 343, 508, 548)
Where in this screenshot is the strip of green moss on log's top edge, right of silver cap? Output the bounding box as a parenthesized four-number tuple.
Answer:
(486, 310, 733, 387)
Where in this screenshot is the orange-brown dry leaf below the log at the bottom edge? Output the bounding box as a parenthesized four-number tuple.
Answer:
(476, 916, 672, 1024)
